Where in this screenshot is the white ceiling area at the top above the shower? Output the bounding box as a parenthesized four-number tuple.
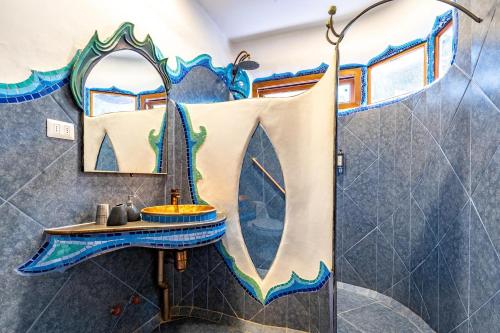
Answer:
(197, 0, 377, 41)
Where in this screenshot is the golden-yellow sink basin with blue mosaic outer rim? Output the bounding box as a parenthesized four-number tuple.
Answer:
(141, 205, 217, 223)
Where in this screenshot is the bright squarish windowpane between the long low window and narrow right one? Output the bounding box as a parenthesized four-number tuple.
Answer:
(369, 47, 425, 103)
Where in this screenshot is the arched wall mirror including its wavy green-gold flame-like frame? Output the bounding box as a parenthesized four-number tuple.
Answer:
(70, 22, 173, 173)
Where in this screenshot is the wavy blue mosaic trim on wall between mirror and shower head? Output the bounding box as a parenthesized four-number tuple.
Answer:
(168, 54, 250, 99)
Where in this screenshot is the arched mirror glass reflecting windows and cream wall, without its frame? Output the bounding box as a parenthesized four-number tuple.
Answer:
(83, 49, 166, 173)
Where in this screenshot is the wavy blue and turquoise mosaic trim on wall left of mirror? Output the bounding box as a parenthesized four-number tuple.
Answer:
(0, 51, 80, 104)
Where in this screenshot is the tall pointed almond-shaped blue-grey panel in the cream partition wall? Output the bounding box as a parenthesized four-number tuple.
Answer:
(239, 126, 286, 278)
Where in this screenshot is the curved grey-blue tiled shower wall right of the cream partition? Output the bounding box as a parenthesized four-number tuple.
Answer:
(336, 0, 500, 332)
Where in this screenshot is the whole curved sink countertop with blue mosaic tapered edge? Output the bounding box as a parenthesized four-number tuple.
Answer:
(17, 214, 226, 275)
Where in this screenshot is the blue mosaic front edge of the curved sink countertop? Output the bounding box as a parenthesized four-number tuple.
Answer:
(17, 220, 226, 275)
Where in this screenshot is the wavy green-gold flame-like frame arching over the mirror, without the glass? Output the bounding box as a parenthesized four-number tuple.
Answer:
(70, 22, 172, 110)
